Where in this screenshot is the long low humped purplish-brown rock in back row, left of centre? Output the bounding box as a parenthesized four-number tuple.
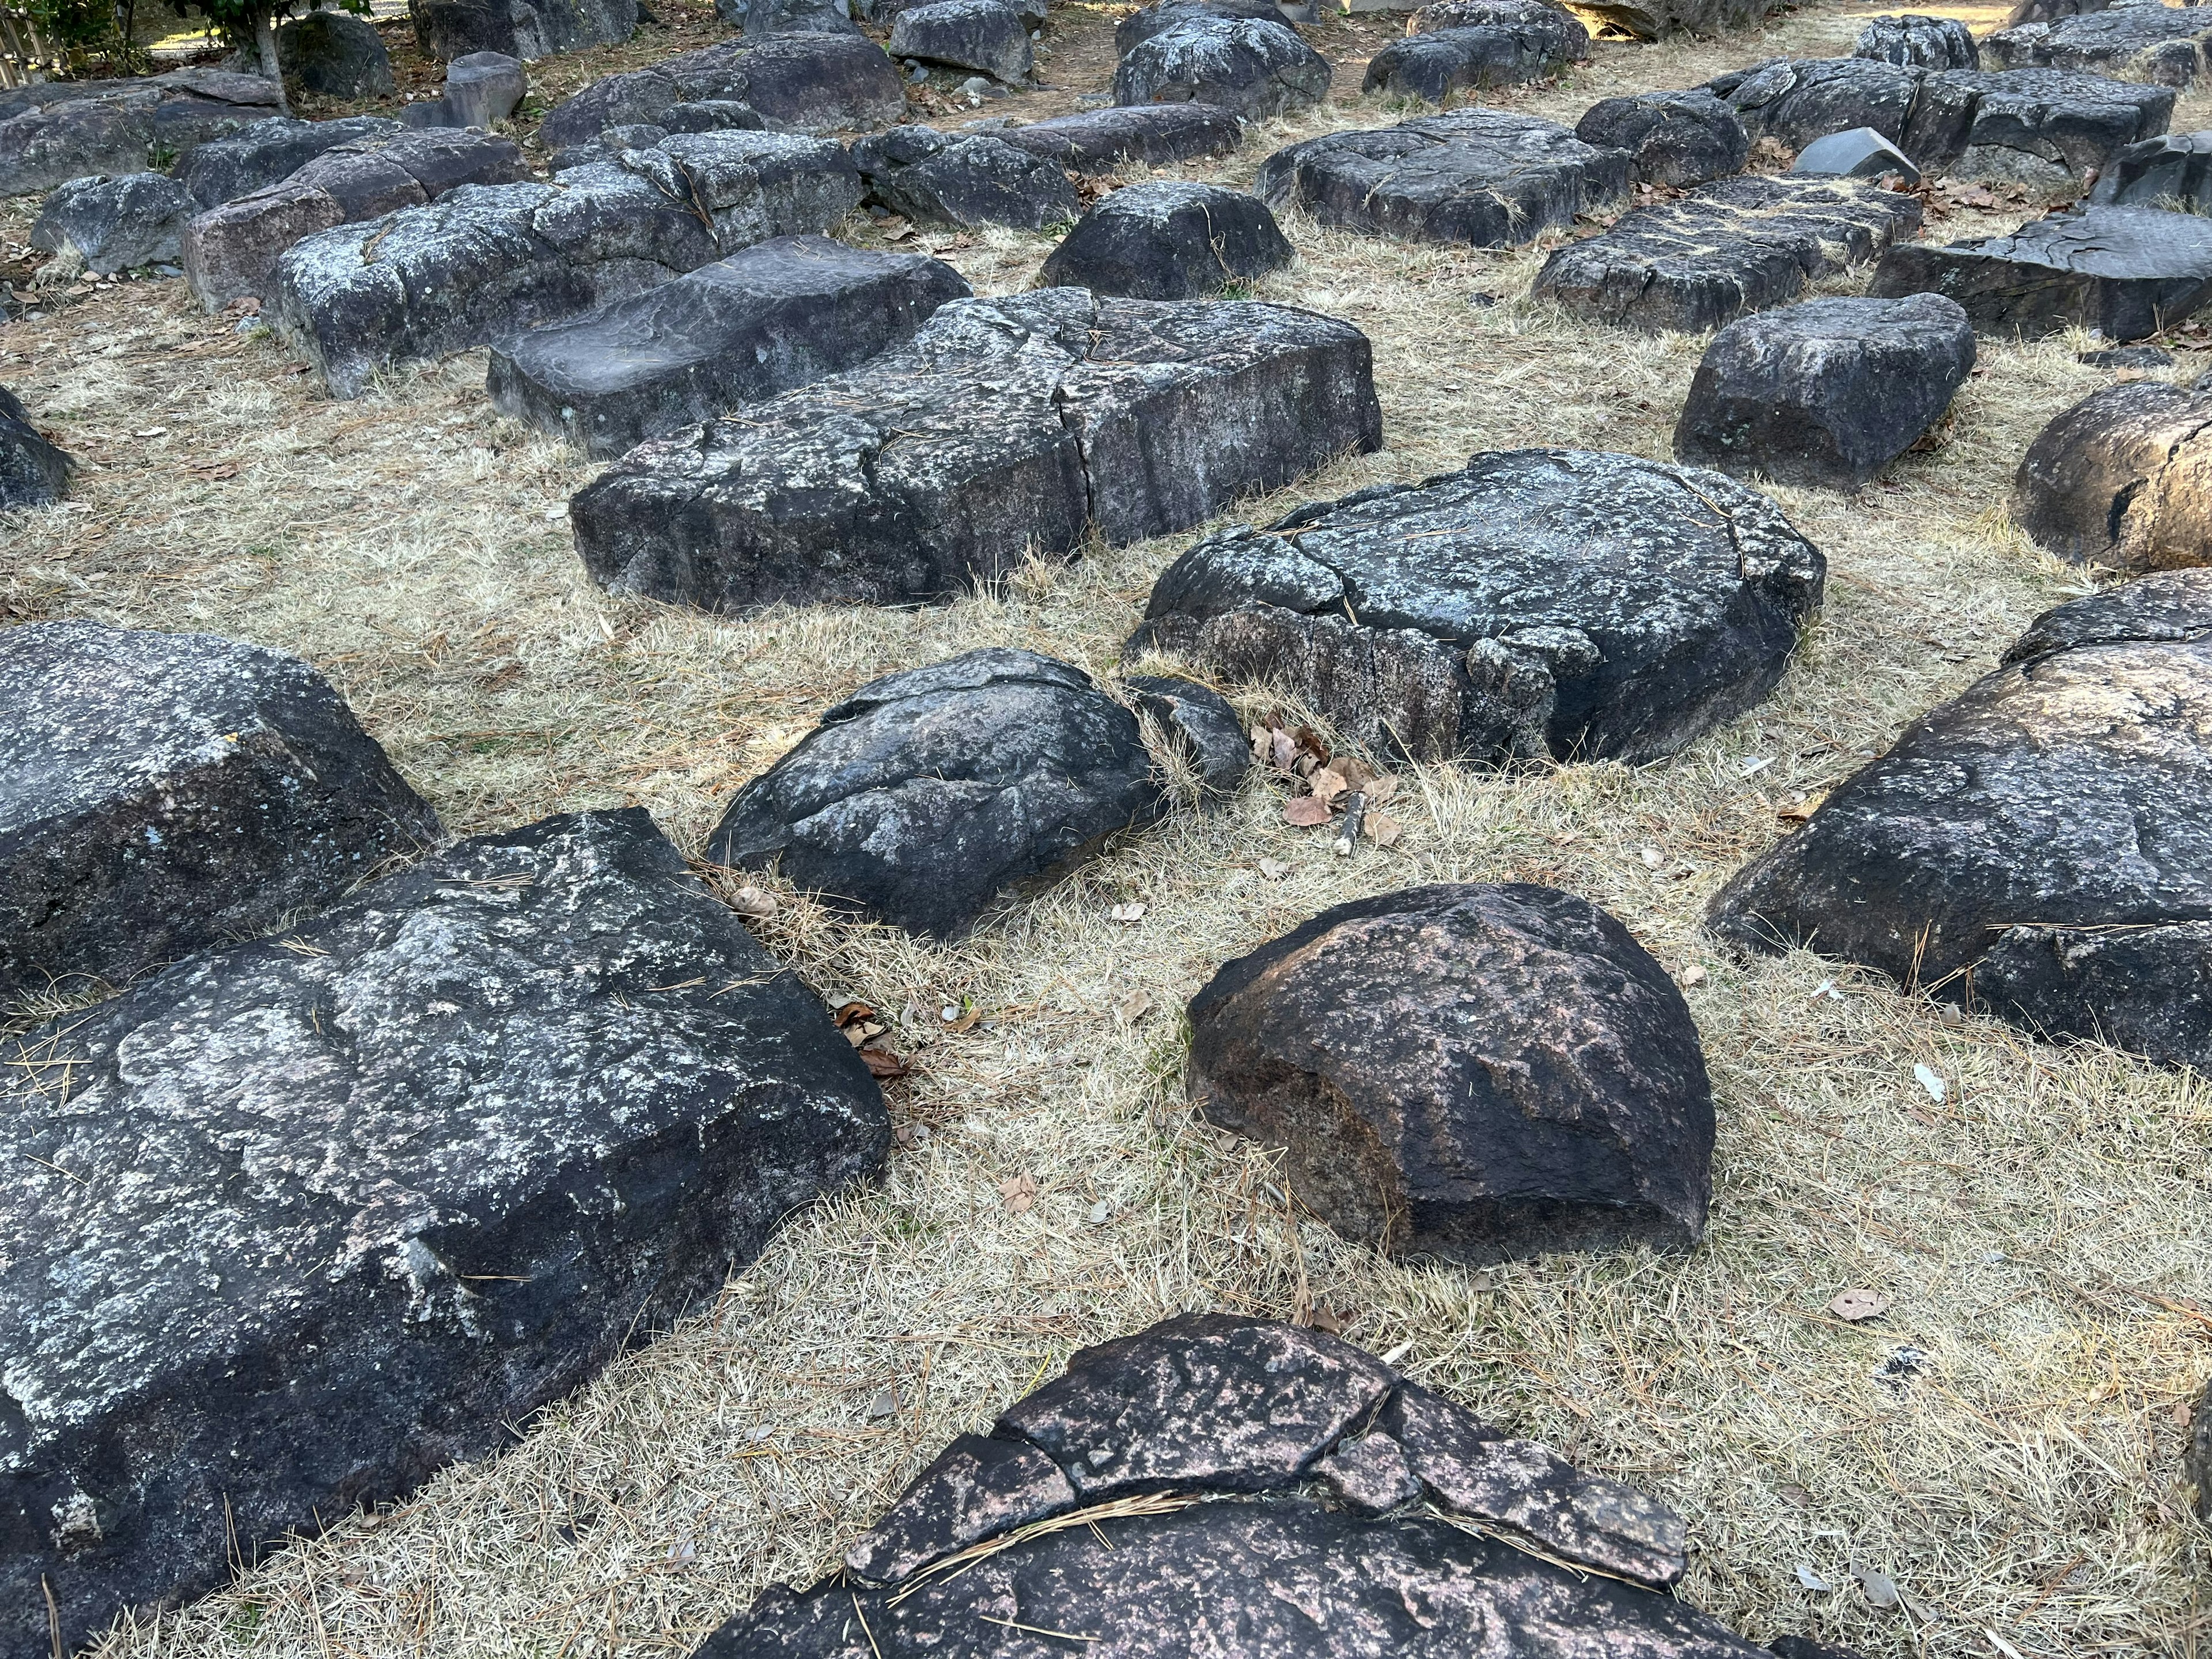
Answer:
(537, 33, 907, 148)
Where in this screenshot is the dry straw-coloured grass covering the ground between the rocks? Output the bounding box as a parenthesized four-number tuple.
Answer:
(0, 7, 2212, 1659)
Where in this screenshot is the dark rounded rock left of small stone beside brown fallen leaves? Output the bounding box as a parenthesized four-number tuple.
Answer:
(708, 646, 1168, 938)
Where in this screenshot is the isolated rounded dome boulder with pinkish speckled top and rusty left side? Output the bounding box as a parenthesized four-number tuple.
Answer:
(1185, 882, 1712, 1263)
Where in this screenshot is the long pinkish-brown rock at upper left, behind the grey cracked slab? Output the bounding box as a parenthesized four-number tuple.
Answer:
(179, 128, 529, 312)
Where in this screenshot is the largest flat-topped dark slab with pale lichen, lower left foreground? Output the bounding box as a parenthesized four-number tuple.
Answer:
(0, 808, 889, 1652)
